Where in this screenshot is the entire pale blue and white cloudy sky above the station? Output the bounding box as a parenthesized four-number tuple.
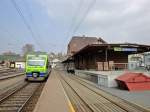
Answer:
(0, 0, 150, 53)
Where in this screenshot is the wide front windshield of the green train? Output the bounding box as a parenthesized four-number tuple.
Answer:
(27, 60, 45, 66)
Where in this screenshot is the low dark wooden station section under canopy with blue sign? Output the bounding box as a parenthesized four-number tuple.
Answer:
(72, 43, 150, 71)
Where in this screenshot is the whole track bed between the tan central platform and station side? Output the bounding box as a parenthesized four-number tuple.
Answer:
(59, 72, 150, 112)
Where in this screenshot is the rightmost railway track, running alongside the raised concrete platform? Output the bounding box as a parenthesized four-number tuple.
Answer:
(72, 77, 150, 112)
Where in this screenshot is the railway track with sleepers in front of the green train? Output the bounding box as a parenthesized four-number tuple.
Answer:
(0, 82, 44, 112)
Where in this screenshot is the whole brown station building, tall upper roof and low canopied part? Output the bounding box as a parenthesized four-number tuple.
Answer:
(65, 36, 150, 71)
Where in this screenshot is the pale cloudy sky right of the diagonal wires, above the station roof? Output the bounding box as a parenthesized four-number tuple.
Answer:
(79, 0, 150, 44)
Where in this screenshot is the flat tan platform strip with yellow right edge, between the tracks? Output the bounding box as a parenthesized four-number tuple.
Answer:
(34, 70, 74, 112)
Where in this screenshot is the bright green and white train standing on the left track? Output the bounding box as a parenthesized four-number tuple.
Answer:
(25, 53, 50, 81)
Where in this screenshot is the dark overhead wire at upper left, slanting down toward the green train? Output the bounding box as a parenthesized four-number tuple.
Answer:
(11, 0, 41, 50)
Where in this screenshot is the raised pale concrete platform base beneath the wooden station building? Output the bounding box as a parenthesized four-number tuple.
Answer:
(75, 70, 150, 87)
